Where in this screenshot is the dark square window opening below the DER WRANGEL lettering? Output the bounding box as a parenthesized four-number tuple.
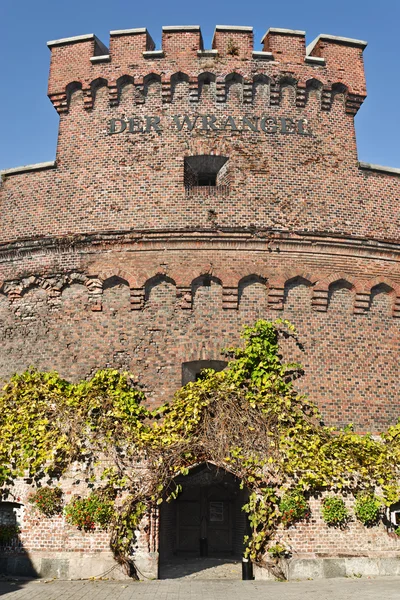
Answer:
(184, 154, 229, 190)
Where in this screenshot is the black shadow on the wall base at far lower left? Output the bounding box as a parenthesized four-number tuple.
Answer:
(0, 502, 38, 596)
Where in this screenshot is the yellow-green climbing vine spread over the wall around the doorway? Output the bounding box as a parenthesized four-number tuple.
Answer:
(0, 319, 400, 576)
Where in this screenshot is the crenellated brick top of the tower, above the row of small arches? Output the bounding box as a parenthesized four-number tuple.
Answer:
(48, 25, 366, 99)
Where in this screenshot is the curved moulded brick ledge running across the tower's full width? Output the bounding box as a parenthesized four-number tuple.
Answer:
(0, 228, 400, 262)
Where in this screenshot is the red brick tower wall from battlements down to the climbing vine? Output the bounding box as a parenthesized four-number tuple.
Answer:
(0, 25, 400, 431)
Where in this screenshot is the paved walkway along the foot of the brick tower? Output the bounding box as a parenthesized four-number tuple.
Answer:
(0, 577, 400, 600)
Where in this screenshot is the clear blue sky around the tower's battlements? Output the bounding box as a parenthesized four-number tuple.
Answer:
(0, 0, 400, 169)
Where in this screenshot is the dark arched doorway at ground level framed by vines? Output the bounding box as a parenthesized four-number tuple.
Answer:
(159, 463, 248, 578)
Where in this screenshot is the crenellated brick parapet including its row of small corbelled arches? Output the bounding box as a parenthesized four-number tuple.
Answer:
(48, 25, 366, 114)
